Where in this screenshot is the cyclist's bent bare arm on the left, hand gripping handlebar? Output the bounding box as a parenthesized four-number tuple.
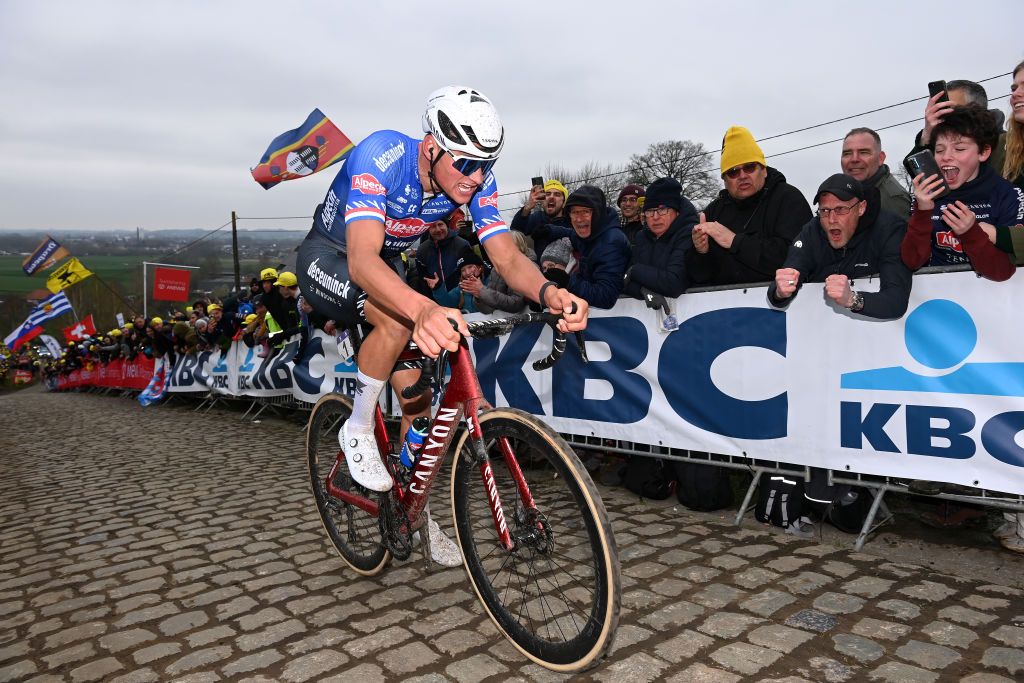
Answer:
(346, 220, 468, 357)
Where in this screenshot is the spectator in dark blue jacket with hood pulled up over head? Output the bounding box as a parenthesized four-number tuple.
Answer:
(552, 185, 630, 308)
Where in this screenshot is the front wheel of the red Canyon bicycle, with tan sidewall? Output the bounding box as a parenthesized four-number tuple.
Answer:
(452, 408, 621, 673)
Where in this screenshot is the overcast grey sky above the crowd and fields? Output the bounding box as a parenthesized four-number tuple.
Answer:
(0, 0, 1024, 229)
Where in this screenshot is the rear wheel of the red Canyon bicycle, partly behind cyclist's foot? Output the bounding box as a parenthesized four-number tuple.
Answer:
(306, 393, 391, 577)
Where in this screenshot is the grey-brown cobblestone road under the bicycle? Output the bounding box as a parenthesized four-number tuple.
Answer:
(0, 391, 1024, 683)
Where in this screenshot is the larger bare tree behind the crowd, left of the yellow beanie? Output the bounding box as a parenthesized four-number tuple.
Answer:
(627, 140, 722, 208)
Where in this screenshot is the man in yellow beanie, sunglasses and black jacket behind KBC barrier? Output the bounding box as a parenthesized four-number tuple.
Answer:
(686, 126, 811, 285)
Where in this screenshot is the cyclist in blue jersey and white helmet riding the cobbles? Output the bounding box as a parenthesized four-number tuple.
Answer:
(296, 86, 587, 553)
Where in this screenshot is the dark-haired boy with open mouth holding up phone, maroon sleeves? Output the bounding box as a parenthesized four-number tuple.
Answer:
(901, 104, 1024, 282)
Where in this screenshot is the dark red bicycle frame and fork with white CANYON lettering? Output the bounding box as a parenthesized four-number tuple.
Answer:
(326, 338, 535, 550)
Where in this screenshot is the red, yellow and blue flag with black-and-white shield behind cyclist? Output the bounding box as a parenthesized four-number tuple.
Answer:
(252, 110, 355, 189)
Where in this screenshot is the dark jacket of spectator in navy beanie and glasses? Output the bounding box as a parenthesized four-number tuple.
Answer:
(625, 198, 697, 299)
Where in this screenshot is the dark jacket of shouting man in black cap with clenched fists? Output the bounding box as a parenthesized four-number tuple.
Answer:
(768, 187, 910, 319)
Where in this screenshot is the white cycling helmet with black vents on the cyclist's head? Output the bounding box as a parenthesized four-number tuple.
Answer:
(423, 85, 505, 164)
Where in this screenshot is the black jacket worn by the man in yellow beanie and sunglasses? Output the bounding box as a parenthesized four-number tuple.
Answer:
(686, 167, 811, 286)
